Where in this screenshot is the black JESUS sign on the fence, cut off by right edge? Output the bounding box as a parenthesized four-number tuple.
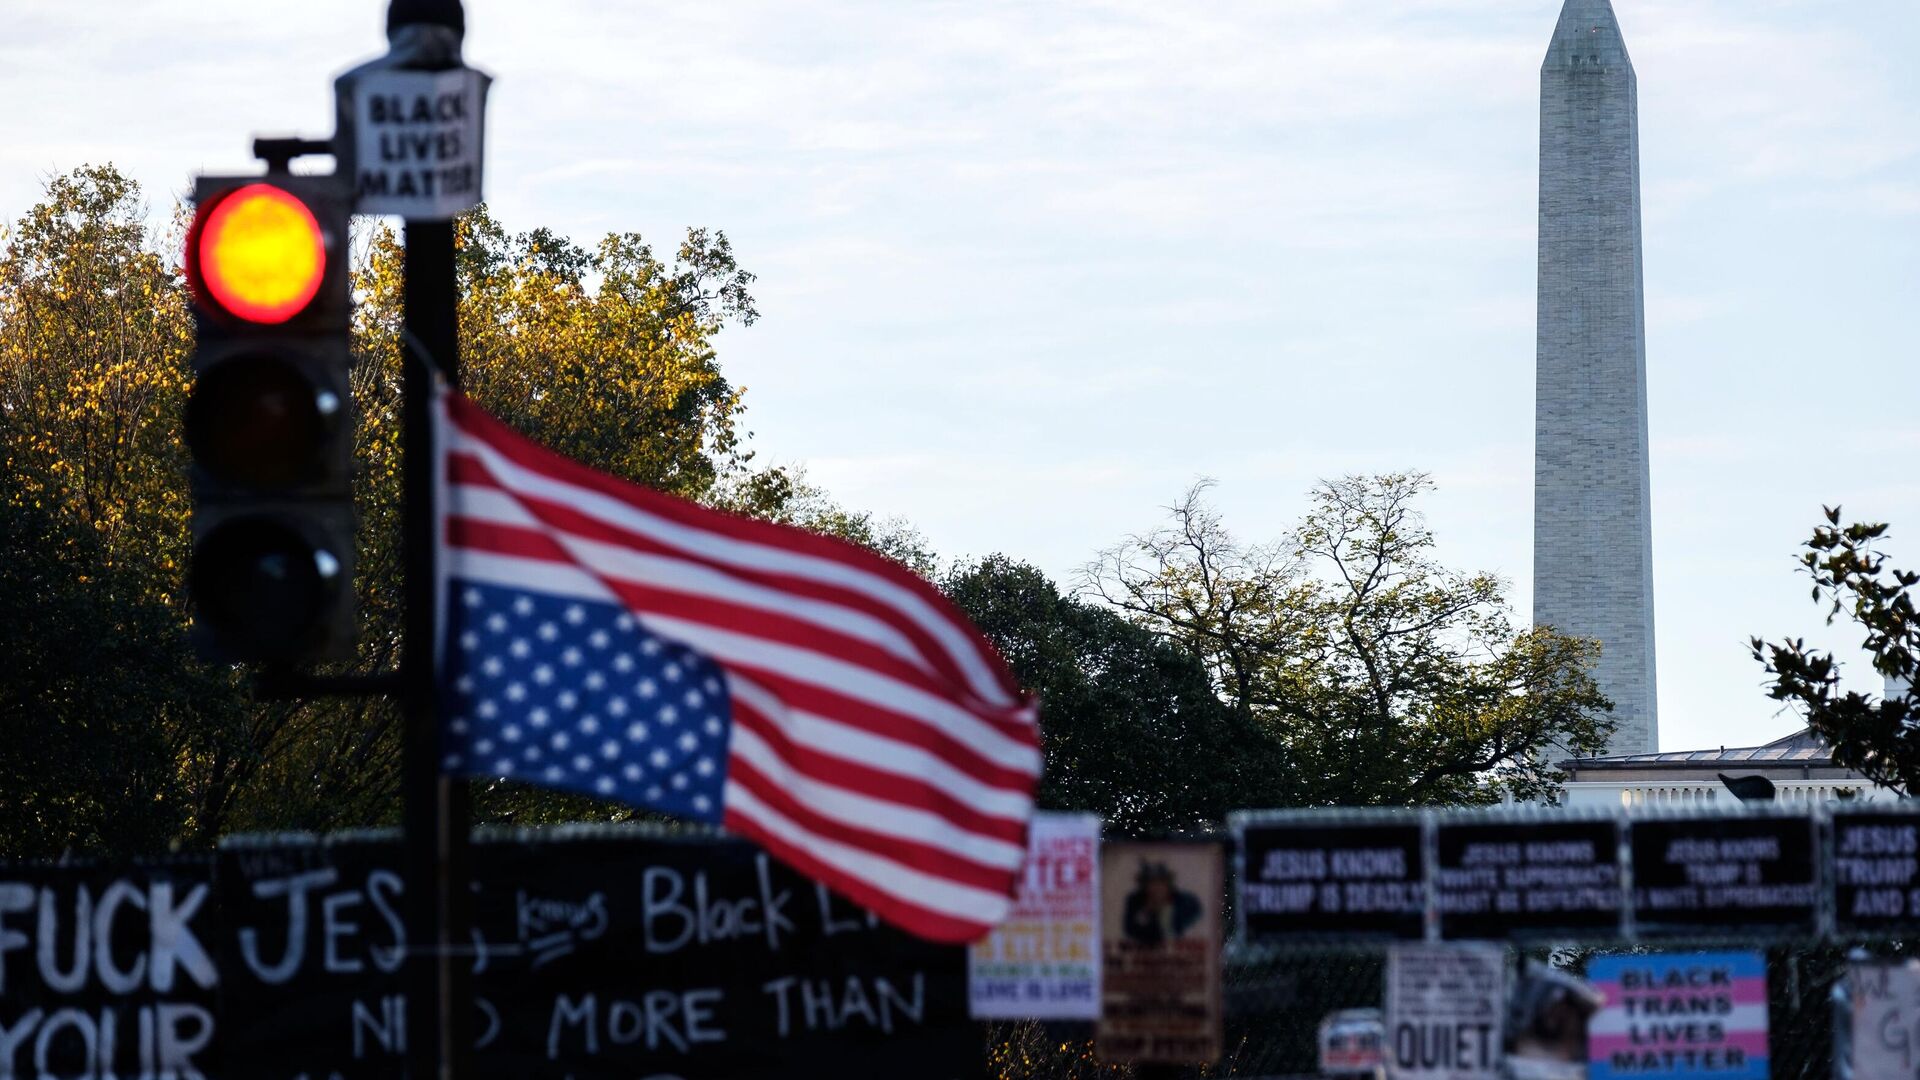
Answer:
(1832, 809, 1920, 936)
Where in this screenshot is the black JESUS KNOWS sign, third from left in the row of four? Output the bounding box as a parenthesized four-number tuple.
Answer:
(1630, 815, 1816, 936)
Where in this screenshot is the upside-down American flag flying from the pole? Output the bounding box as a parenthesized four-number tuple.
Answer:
(436, 392, 1041, 942)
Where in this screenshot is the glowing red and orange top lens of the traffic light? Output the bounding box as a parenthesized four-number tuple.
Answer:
(186, 183, 326, 323)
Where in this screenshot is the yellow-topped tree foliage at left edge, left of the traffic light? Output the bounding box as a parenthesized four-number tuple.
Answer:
(0, 167, 263, 855)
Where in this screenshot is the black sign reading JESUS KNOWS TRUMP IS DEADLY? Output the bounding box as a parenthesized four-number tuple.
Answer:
(1240, 819, 1427, 942)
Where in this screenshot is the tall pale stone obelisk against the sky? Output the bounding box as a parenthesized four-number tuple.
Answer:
(1534, 0, 1659, 753)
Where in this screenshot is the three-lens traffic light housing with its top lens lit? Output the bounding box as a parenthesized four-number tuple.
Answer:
(184, 173, 353, 661)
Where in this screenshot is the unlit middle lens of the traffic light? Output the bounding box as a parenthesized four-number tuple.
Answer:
(186, 356, 340, 488)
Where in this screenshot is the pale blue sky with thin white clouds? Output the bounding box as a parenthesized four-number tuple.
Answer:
(0, 0, 1920, 749)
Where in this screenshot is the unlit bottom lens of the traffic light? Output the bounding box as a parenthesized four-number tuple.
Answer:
(192, 517, 340, 661)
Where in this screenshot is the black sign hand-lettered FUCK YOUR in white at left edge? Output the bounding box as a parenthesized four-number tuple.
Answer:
(0, 849, 219, 1076)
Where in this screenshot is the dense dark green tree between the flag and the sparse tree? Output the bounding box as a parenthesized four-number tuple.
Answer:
(941, 555, 1286, 836)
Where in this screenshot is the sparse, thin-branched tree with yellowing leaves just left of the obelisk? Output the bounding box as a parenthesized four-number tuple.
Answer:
(1085, 473, 1613, 805)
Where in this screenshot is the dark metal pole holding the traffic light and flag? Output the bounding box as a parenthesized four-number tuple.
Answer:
(388, 0, 472, 1080)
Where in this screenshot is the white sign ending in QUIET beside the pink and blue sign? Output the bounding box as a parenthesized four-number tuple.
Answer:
(1386, 945, 1507, 1080)
